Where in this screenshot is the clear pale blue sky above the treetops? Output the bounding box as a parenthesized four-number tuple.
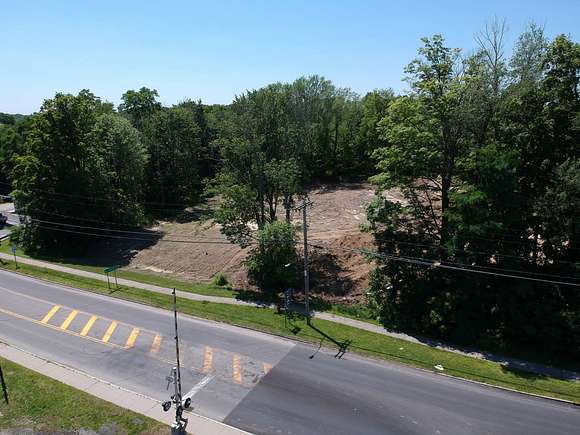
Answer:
(0, 0, 580, 113)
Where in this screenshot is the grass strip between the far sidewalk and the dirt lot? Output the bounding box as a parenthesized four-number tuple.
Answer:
(0, 241, 236, 298)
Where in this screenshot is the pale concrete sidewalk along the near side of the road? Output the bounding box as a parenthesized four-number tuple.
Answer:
(0, 342, 248, 435)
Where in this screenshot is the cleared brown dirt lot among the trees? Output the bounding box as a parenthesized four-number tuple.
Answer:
(128, 183, 394, 299)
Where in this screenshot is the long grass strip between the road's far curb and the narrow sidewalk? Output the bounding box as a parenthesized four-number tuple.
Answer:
(2, 262, 580, 403)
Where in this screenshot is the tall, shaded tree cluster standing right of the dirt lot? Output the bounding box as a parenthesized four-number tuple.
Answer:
(368, 22, 580, 364)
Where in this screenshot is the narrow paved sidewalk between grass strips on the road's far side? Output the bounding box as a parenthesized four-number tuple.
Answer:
(0, 253, 580, 382)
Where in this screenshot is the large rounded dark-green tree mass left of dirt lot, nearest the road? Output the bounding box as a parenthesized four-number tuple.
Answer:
(13, 90, 144, 253)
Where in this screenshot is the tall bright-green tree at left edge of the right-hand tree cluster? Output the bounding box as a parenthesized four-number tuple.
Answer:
(373, 35, 464, 249)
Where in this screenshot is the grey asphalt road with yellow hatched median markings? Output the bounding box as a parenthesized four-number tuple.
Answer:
(0, 271, 580, 435)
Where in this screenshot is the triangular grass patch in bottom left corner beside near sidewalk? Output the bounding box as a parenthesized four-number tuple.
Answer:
(0, 358, 168, 434)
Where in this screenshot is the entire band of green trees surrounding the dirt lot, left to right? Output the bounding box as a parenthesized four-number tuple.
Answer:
(0, 20, 580, 364)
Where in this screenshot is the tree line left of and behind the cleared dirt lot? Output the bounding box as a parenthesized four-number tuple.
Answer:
(0, 76, 394, 252)
